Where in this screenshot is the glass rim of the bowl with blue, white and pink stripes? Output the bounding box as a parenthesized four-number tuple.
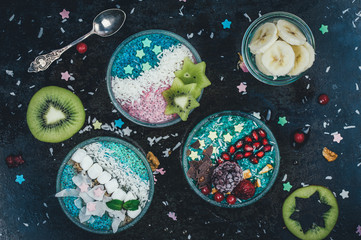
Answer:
(106, 29, 203, 128)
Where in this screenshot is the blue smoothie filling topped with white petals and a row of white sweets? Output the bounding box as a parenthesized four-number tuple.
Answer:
(56, 141, 150, 233)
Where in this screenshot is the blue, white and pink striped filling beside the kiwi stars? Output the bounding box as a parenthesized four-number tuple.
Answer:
(111, 31, 196, 124)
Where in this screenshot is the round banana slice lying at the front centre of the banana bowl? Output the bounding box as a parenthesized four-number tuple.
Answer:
(262, 40, 295, 76)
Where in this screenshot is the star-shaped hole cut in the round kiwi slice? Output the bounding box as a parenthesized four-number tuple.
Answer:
(290, 191, 331, 233)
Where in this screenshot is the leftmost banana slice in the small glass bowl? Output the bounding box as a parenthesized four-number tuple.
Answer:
(249, 22, 278, 54)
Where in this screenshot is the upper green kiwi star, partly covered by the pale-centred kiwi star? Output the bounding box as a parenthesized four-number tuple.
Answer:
(175, 57, 211, 98)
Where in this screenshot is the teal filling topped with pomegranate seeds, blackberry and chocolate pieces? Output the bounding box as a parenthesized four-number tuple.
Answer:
(183, 112, 279, 207)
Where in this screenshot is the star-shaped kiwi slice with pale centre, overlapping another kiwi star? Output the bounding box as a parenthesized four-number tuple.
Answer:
(162, 78, 199, 121)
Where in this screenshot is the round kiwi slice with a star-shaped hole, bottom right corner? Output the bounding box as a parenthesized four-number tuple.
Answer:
(282, 185, 338, 240)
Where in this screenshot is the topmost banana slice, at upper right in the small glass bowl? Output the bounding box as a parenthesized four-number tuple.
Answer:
(277, 19, 306, 45)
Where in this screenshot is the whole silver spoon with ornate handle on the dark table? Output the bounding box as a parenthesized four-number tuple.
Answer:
(28, 8, 126, 72)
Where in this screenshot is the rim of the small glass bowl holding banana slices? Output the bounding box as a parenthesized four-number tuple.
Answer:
(241, 11, 316, 86)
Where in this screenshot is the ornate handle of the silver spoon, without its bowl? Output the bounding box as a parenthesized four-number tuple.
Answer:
(28, 30, 94, 73)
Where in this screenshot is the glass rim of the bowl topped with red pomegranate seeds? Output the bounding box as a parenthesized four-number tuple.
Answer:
(181, 110, 281, 208)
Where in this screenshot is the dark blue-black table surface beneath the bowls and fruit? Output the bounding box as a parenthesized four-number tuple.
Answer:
(0, 0, 361, 240)
